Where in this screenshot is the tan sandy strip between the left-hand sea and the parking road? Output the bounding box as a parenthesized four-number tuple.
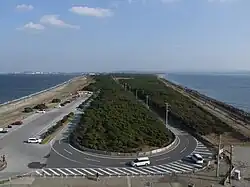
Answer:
(0, 76, 92, 127)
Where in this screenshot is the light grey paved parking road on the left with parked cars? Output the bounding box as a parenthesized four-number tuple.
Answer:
(0, 95, 88, 178)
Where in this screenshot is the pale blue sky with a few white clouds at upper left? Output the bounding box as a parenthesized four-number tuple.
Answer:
(0, 0, 250, 72)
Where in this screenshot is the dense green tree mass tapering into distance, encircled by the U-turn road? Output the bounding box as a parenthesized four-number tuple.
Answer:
(71, 75, 174, 153)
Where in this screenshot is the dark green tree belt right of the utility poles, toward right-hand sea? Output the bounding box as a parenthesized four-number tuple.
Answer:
(117, 75, 243, 139)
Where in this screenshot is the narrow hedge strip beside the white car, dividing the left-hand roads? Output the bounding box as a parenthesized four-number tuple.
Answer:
(41, 112, 74, 144)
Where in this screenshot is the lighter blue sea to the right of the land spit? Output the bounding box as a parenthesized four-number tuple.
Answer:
(165, 73, 250, 112)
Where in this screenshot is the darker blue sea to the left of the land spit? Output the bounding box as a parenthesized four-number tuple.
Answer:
(0, 74, 74, 104)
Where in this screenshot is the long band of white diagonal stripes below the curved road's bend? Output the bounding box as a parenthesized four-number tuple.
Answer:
(35, 160, 203, 177)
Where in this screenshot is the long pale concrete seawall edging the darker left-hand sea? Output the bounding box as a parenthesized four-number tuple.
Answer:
(0, 77, 76, 113)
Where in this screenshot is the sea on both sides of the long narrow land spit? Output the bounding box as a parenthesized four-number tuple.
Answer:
(0, 73, 250, 112)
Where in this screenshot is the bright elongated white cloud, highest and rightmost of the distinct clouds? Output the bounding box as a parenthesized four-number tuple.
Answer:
(69, 6, 113, 18)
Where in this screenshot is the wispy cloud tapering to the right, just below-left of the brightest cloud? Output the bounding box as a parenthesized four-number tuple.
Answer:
(40, 15, 80, 29)
